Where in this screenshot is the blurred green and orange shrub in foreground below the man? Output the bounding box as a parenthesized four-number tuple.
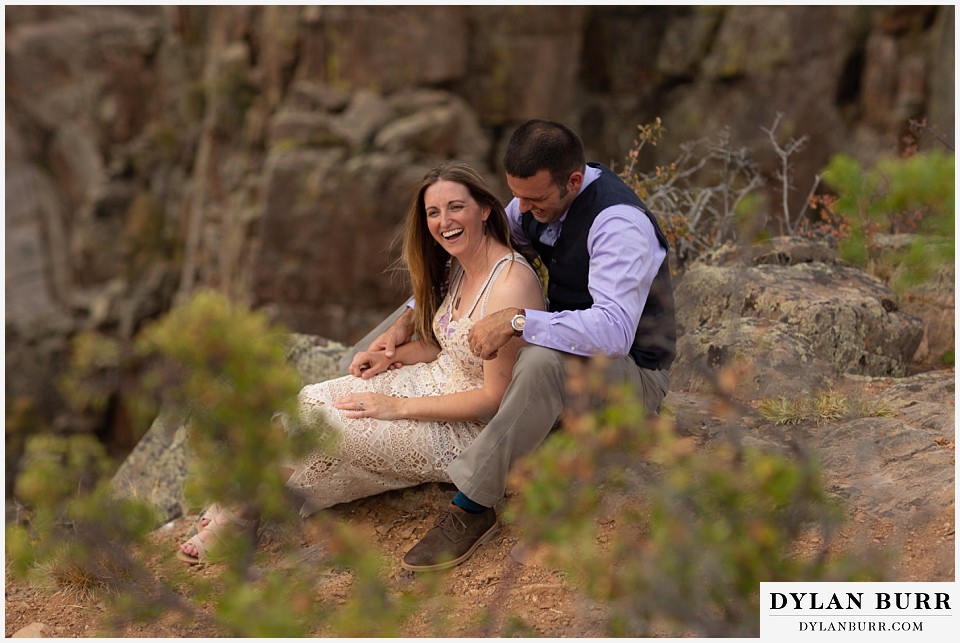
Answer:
(511, 360, 878, 637)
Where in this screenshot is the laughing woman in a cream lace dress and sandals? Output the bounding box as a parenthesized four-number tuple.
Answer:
(177, 161, 544, 564)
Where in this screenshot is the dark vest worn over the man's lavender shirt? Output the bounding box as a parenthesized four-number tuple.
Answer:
(521, 163, 677, 370)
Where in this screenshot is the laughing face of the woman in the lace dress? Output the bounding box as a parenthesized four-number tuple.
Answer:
(423, 179, 490, 257)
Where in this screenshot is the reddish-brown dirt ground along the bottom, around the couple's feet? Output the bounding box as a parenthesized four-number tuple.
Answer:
(4, 472, 954, 638)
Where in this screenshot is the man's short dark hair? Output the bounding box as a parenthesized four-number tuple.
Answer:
(503, 119, 586, 187)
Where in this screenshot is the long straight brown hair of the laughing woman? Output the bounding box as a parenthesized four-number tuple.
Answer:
(401, 161, 512, 345)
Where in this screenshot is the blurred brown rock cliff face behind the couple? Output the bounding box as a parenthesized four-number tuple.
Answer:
(5, 6, 954, 458)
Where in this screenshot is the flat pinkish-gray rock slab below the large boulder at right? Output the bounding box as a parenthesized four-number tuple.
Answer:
(664, 370, 956, 581)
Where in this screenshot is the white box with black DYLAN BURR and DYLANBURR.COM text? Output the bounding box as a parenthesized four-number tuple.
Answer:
(760, 583, 960, 641)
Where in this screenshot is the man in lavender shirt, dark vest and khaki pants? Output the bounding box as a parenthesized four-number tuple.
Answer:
(351, 120, 676, 571)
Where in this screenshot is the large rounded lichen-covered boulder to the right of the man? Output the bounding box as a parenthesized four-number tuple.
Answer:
(671, 241, 923, 399)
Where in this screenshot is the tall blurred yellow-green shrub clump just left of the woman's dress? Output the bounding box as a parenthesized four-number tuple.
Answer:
(130, 292, 312, 518)
